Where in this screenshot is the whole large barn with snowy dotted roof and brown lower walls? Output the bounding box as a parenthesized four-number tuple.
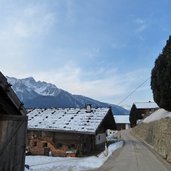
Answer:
(27, 108, 115, 156)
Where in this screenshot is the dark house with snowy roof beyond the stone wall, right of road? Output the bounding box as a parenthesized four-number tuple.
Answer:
(130, 102, 159, 127)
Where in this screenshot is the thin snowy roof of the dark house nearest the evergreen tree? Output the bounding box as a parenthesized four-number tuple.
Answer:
(134, 102, 159, 109)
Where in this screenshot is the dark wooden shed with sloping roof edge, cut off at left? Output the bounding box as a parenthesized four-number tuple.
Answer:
(0, 72, 27, 171)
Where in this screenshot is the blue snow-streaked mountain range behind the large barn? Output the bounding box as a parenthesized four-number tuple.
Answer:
(7, 77, 128, 114)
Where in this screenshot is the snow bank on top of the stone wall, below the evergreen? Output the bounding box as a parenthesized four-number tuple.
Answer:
(143, 109, 171, 123)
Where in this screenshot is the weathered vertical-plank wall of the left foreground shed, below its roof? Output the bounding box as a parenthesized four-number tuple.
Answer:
(0, 114, 27, 171)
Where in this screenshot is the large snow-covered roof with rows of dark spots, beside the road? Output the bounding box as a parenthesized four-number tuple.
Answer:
(28, 108, 109, 134)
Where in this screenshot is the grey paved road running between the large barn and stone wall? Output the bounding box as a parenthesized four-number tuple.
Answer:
(91, 131, 171, 171)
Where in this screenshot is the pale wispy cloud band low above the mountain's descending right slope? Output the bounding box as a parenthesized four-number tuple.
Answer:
(30, 64, 150, 102)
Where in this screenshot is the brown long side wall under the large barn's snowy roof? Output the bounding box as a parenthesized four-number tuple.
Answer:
(27, 130, 96, 156)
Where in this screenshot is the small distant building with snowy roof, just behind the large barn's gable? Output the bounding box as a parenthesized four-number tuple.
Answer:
(114, 115, 130, 131)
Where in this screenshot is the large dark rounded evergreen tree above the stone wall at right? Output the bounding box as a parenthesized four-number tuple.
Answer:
(151, 36, 171, 111)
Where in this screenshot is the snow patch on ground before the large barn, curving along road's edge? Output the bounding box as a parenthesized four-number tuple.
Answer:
(25, 141, 123, 171)
